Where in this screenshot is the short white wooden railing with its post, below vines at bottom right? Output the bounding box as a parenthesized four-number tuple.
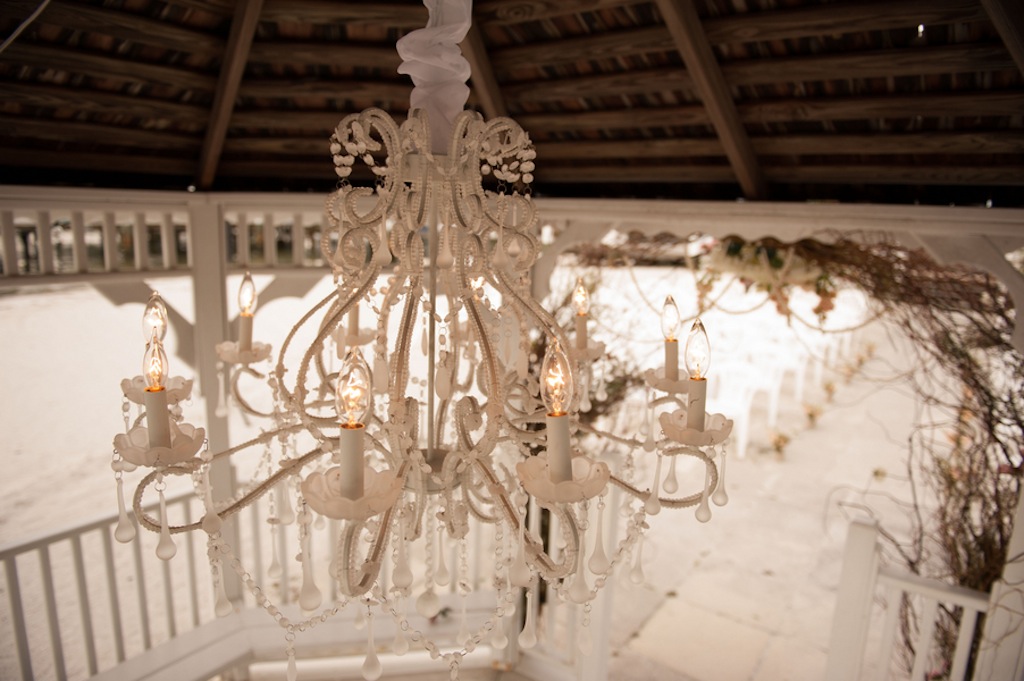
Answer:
(825, 519, 989, 681)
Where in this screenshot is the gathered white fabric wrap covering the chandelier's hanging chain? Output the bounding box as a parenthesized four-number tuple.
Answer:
(397, 0, 473, 154)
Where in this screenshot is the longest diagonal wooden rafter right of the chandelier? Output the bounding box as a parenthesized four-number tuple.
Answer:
(657, 0, 768, 199)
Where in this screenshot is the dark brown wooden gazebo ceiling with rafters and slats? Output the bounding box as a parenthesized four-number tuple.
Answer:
(0, 0, 1024, 206)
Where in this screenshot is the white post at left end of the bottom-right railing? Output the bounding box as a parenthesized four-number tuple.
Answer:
(825, 518, 879, 681)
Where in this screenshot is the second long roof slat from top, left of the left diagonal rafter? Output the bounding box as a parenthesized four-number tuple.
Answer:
(0, 42, 217, 92)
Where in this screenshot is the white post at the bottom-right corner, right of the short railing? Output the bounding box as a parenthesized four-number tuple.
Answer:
(974, 489, 1024, 681)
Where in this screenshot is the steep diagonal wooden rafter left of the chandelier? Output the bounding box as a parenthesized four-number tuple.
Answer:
(196, 0, 263, 189)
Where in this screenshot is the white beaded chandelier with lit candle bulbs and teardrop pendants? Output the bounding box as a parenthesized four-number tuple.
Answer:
(113, 0, 732, 681)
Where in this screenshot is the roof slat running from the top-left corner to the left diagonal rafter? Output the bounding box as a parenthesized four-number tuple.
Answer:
(4, 0, 224, 56)
